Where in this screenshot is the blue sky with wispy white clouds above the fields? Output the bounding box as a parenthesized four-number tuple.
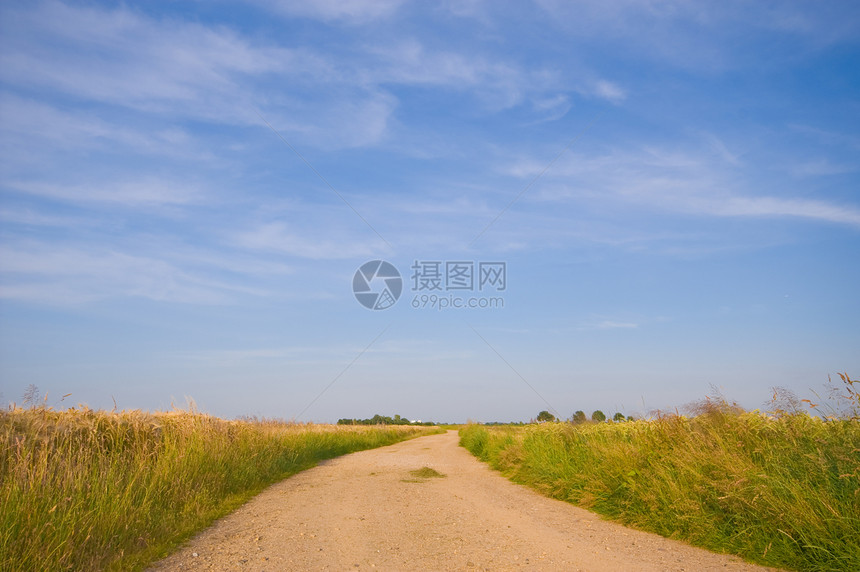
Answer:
(0, 0, 860, 422)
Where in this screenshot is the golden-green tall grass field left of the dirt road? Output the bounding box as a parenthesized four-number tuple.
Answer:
(0, 408, 434, 571)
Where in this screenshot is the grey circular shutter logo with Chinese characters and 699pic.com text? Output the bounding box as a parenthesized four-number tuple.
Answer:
(352, 260, 508, 311)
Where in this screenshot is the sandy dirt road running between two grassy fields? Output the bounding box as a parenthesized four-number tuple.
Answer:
(151, 431, 780, 572)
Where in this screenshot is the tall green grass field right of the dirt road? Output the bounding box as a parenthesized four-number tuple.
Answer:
(460, 409, 860, 570)
